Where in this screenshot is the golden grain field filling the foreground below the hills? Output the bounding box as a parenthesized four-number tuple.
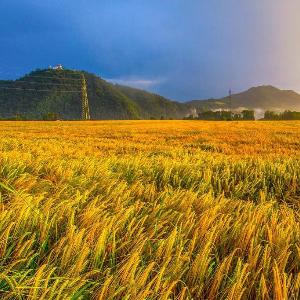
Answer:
(0, 121, 300, 300)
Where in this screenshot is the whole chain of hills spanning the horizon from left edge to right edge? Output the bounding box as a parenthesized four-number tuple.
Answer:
(0, 70, 300, 120)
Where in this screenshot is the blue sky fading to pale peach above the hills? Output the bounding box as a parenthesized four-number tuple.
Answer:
(0, 0, 300, 100)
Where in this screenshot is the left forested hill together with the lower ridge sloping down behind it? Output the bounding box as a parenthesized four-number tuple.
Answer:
(0, 70, 189, 120)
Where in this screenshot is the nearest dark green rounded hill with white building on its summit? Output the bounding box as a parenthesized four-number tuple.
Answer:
(0, 70, 140, 119)
